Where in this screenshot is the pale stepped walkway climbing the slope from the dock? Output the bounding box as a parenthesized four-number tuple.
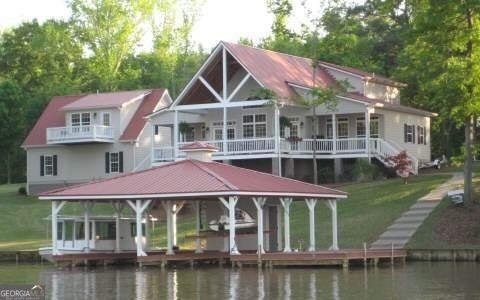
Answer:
(370, 173, 463, 249)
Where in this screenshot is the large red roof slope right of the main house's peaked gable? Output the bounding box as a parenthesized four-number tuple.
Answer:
(223, 42, 337, 99)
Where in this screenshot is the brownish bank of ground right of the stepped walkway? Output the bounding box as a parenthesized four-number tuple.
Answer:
(407, 176, 480, 249)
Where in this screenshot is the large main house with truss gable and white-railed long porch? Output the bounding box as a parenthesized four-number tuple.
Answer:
(148, 42, 435, 180)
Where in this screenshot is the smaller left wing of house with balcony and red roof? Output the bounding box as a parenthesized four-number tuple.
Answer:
(22, 89, 172, 194)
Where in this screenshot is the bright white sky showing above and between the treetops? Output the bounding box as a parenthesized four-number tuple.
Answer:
(0, 0, 328, 49)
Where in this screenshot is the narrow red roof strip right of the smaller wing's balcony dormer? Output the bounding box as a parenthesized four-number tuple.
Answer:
(120, 89, 166, 141)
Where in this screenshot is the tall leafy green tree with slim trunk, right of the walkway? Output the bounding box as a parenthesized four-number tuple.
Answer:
(406, 0, 480, 203)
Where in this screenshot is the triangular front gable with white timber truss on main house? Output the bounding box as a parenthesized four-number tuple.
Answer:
(172, 43, 266, 109)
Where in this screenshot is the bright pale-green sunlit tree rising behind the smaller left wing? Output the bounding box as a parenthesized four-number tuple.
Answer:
(68, 0, 157, 90)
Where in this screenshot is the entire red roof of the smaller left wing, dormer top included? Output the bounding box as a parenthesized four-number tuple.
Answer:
(22, 89, 166, 147)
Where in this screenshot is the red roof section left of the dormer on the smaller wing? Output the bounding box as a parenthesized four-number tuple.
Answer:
(22, 95, 85, 146)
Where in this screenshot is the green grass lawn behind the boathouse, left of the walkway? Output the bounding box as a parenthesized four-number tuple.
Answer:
(0, 175, 450, 250)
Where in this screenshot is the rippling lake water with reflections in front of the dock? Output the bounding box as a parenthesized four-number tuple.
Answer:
(0, 262, 480, 300)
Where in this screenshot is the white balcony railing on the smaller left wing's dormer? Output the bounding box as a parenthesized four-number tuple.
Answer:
(47, 125, 115, 143)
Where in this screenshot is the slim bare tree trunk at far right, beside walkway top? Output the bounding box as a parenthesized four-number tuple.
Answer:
(463, 115, 475, 204)
